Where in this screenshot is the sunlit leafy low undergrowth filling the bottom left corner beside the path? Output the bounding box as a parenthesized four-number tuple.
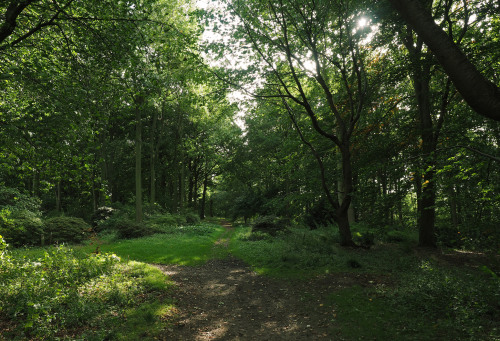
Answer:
(0, 246, 173, 340)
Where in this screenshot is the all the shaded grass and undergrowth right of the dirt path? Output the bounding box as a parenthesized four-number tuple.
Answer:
(231, 227, 500, 340)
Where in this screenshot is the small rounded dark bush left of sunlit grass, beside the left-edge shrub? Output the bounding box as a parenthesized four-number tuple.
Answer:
(44, 217, 92, 244)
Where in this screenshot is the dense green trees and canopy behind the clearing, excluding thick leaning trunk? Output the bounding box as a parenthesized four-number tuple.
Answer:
(0, 0, 500, 250)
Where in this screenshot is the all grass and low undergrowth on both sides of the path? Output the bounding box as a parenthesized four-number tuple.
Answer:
(0, 219, 500, 340)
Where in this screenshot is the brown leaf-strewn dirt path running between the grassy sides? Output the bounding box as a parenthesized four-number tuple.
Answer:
(157, 223, 380, 341)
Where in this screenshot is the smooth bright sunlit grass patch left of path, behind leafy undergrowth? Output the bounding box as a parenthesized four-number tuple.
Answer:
(82, 223, 224, 266)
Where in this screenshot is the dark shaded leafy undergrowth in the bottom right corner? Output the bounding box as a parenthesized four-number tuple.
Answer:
(385, 261, 500, 340)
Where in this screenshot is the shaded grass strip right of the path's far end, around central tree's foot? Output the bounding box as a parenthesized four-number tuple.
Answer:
(230, 227, 418, 278)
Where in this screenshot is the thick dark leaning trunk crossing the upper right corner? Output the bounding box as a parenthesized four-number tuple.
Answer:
(389, 0, 500, 121)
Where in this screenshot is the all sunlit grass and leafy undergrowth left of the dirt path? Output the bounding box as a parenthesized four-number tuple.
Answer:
(0, 219, 227, 340)
